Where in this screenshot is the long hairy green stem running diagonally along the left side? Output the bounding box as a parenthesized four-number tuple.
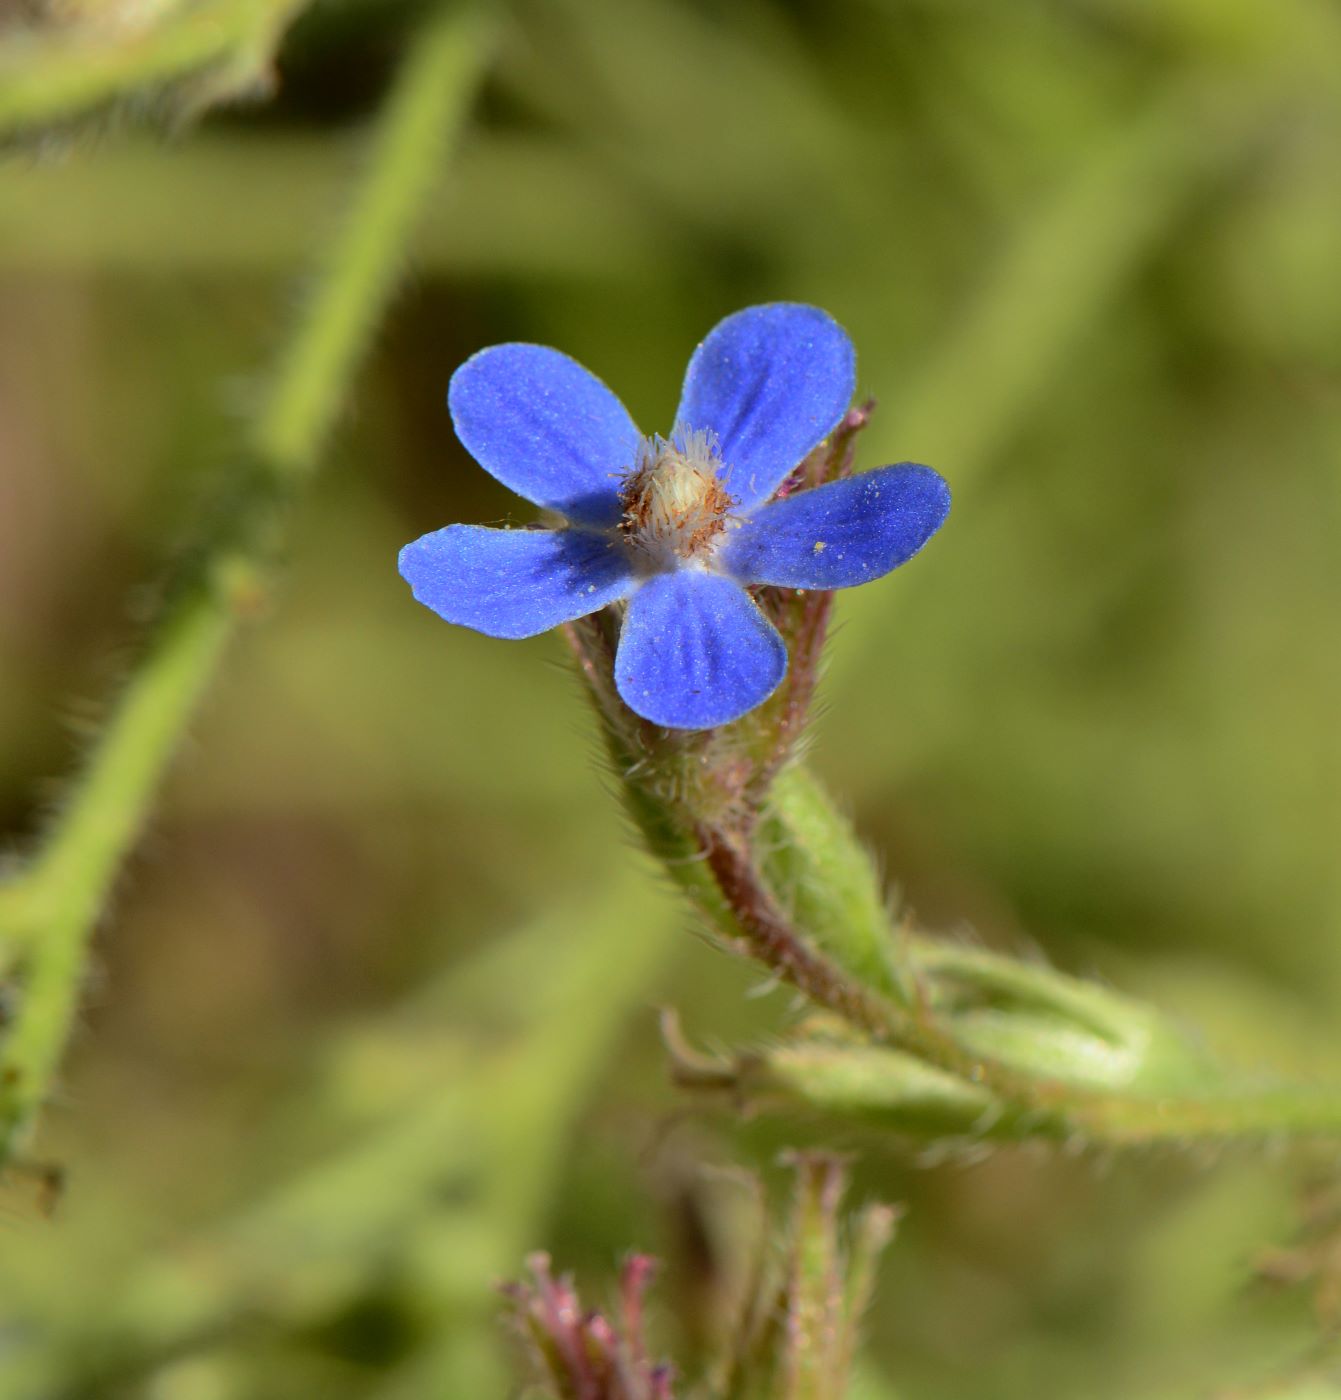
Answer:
(0, 0, 501, 1154)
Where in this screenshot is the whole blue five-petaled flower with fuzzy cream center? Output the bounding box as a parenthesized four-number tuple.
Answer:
(400, 302, 950, 729)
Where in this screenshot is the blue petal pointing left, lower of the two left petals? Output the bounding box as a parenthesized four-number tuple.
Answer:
(400, 525, 633, 637)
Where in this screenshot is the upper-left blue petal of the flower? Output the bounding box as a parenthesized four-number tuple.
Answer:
(447, 344, 641, 525)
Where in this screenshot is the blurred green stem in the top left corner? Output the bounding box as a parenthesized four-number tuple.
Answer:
(0, 0, 308, 137)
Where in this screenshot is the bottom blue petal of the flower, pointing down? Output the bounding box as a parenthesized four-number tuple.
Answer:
(615, 571, 787, 729)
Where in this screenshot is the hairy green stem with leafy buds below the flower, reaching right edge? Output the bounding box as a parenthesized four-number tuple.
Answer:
(702, 766, 1341, 1145)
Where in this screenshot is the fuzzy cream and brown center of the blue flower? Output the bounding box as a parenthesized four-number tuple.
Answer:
(619, 428, 735, 564)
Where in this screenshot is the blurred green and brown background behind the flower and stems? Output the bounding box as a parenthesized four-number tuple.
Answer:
(0, 0, 1341, 1400)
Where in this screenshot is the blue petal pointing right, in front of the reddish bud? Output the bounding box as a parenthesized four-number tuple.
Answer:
(718, 462, 950, 588)
